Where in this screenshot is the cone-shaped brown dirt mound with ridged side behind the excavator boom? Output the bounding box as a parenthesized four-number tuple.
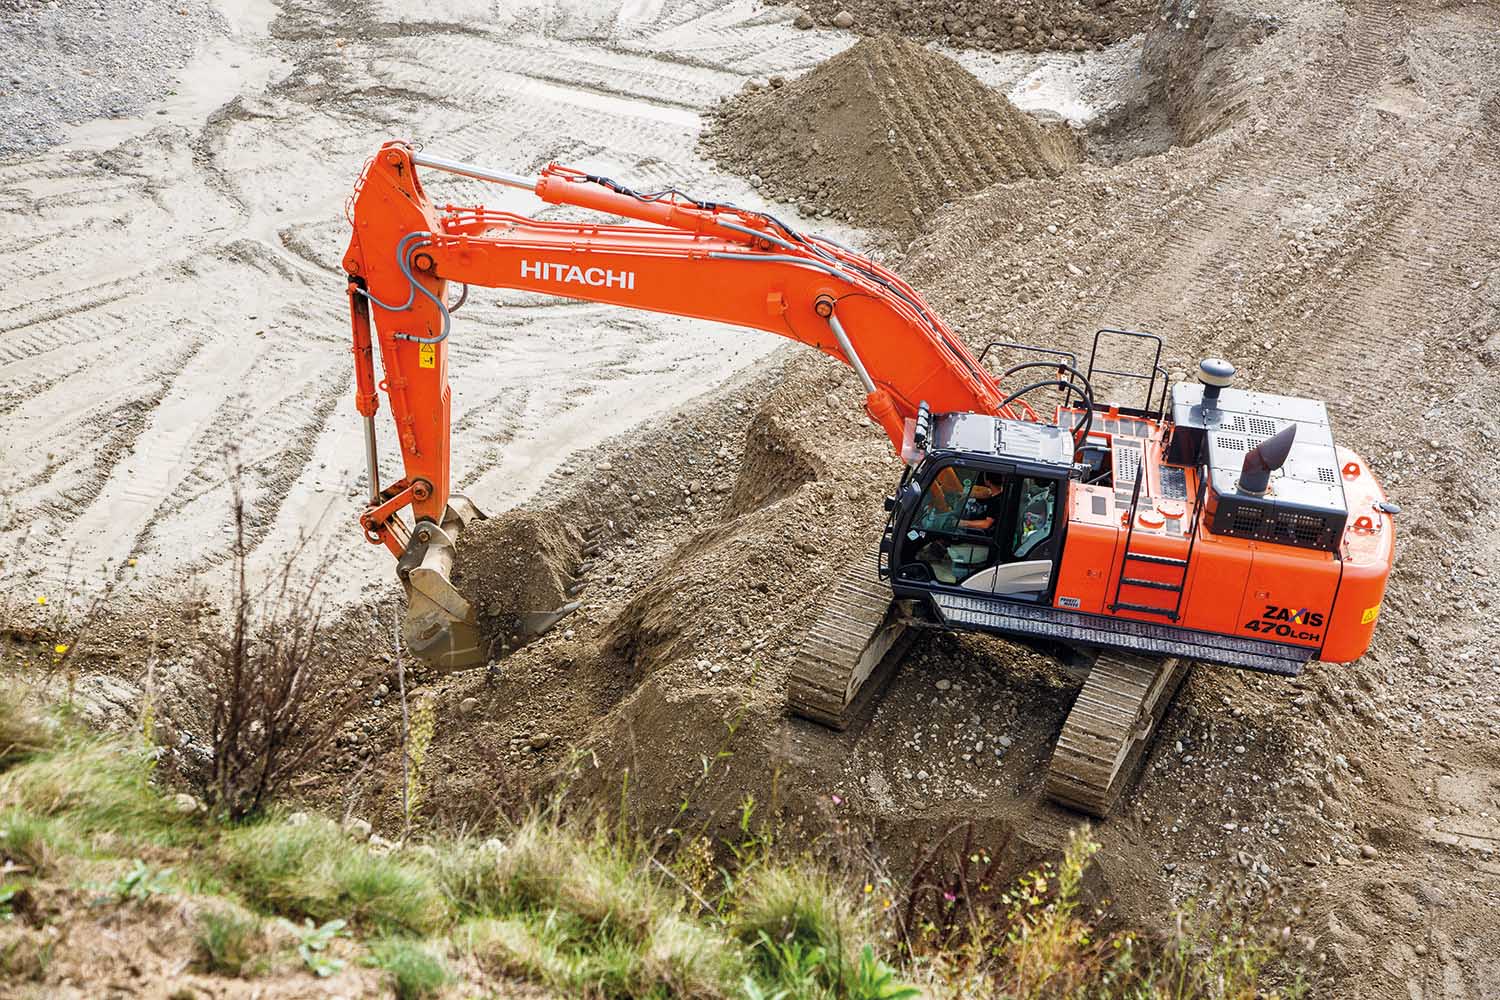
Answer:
(704, 36, 1079, 232)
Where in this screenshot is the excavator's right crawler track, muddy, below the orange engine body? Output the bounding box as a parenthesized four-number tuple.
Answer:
(1046, 651, 1193, 819)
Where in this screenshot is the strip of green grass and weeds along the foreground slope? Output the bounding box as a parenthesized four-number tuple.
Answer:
(0, 695, 1298, 1000)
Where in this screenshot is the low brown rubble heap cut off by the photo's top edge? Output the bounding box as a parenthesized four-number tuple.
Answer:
(774, 0, 1155, 52)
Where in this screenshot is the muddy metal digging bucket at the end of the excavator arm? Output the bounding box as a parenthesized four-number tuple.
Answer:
(396, 495, 489, 672)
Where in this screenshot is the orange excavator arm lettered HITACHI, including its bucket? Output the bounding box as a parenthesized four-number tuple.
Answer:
(344, 142, 1013, 667)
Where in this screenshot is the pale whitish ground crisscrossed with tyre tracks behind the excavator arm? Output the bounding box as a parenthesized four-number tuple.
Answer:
(0, 0, 870, 597)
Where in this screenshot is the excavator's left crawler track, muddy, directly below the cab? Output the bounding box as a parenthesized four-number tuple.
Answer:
(786, 558, 915, 730)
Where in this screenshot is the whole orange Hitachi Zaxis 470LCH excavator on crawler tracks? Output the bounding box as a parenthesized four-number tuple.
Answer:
(344, 141, 1398, 817)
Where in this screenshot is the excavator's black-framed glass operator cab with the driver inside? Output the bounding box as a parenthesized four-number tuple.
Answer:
(882, 414, 1076, 603)
